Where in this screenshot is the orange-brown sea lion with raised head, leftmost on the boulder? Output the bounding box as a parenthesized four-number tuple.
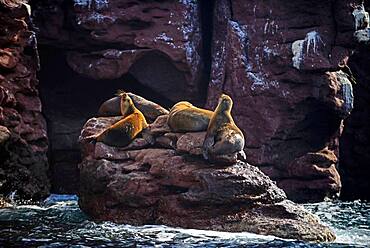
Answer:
(85, 92, 148, 147)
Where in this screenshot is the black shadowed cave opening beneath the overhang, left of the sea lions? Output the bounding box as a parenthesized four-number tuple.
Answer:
(38, 46, 173, 193)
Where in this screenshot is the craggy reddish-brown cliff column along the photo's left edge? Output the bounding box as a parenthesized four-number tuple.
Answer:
(0, 1, 50, 199)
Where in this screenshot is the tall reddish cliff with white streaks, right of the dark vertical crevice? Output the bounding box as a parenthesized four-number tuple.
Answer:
(207, 0, 360, 201)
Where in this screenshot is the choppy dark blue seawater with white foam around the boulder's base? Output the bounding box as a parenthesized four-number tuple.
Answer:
(0, 195, 370, 248)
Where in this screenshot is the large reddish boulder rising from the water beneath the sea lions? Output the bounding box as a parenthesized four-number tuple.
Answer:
(79, 115, 335, 241)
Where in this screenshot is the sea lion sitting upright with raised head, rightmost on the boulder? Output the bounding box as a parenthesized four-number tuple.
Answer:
(203, 94, 245, 161)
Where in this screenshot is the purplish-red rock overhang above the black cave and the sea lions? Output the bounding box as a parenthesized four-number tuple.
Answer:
(32, 0, 206, 102)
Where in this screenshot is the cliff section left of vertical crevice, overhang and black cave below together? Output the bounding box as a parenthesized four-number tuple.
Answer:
(30, 0, 207, 193)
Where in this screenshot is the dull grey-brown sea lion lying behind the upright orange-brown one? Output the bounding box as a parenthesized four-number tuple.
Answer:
(98, 92, 168, 122)
